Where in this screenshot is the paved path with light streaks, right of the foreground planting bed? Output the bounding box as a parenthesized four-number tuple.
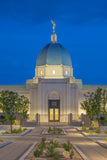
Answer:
(66, 128, 107, 160)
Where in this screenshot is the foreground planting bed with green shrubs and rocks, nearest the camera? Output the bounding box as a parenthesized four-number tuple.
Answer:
(25, 138, 82, 160)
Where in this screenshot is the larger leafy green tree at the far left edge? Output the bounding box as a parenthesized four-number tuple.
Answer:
(0, 90, 18, 133)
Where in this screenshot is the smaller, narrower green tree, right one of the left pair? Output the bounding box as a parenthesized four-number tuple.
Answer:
(16, 95, 30, 129)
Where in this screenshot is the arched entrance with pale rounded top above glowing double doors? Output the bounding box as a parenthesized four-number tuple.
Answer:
(48, 92, 60, 122)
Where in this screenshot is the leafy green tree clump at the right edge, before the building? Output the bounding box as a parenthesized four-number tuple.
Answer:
(81, 88, 107, 127)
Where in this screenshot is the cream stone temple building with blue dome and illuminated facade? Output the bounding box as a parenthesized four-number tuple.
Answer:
(0, 22, 107, 123)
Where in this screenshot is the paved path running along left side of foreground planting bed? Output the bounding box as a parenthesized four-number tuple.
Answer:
(0, 127, 42, 160)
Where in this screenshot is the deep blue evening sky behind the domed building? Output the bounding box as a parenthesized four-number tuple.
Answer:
(0, 0, 107, 84)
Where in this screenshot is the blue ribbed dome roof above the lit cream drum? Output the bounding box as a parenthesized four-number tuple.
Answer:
(36, 42, 72, 66)
